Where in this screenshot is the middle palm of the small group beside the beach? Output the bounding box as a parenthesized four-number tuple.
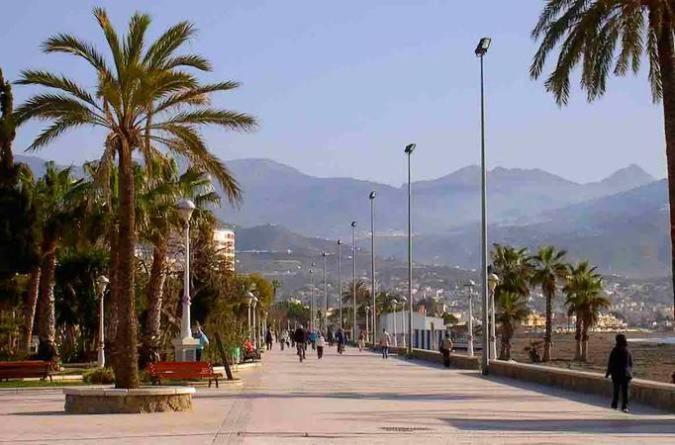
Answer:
(531, 246, 568, 362)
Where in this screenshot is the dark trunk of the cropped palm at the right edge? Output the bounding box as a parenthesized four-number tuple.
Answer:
(657, 6, 675, 316)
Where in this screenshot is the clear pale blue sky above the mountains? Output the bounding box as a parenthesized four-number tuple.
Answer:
(0, 0, 666, 185)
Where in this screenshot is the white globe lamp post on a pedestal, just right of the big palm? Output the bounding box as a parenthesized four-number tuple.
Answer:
(173, 199, 199, 362)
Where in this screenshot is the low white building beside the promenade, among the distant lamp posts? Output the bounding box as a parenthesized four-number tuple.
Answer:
(376, 311, 446, 350)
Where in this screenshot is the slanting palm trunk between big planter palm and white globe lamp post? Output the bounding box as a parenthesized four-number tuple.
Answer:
(141, 237, 167, 362)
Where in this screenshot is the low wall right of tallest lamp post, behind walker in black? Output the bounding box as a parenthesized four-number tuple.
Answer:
(489, 360, 675, 412)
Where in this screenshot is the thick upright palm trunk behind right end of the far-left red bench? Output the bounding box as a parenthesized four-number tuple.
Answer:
(38, 235, 59, 360)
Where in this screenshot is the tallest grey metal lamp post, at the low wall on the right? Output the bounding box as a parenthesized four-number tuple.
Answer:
(474, 37, 492, 375)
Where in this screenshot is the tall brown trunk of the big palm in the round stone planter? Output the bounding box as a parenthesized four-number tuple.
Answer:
(114, 138, 139, 389)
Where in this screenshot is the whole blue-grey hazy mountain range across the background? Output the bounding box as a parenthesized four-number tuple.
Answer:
(17, 156, 670, 278)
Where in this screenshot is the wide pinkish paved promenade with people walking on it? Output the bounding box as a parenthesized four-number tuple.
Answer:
(0, 345, 675, 445)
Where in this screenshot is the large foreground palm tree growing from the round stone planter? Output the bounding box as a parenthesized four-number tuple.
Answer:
(17, 8, 256, 388)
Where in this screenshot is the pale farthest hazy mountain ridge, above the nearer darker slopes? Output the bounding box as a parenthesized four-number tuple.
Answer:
(220, 159, 654, 237)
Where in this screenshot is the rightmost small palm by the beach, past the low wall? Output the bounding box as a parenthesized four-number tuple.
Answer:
(563, 261, 602, 360)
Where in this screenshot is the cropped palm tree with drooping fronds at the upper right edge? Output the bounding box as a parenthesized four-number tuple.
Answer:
(530, 0, 675, 320)
